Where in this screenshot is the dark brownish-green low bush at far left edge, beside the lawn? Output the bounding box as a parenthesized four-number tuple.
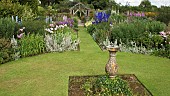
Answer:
(0, 38, 14, 64)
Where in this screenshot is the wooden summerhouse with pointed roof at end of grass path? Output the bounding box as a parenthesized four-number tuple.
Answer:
(70, 2, 90, 17)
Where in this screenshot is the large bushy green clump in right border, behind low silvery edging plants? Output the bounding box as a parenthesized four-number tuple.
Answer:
(112, 20, 165, 48)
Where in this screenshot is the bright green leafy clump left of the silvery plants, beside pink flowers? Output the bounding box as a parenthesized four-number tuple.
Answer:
(18, 34, 45, 57)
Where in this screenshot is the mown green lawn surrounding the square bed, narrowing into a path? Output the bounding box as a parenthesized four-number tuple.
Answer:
(0, 28, 170, 96)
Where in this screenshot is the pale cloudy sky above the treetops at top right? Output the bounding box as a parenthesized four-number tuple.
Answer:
(115, 0, 170, 7)
